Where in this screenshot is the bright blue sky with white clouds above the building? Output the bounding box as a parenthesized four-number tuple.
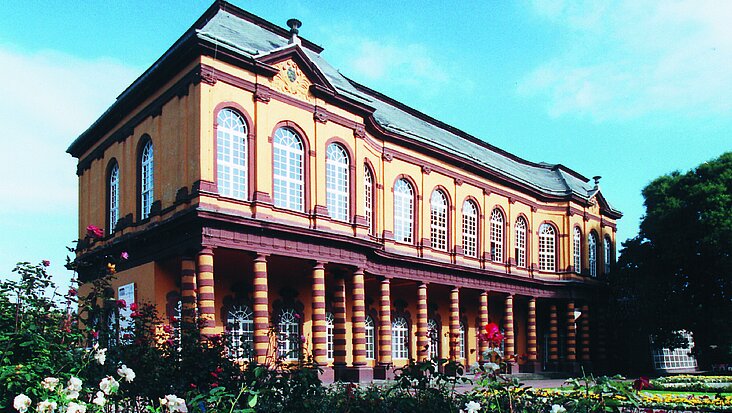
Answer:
(0, 0, 732, 290)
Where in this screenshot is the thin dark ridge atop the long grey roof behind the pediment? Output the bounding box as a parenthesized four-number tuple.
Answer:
(338, 71, 589, 182)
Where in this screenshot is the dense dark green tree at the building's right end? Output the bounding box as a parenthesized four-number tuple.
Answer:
(611, 152, 732, 367)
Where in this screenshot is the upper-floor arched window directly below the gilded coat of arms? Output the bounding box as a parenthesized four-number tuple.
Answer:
(272, 128, 305, 211)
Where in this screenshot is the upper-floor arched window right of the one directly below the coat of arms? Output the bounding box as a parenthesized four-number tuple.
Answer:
(325, 143, 350, 222)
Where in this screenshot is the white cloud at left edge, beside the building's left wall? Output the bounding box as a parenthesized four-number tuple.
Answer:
(0, 47, 138, 211)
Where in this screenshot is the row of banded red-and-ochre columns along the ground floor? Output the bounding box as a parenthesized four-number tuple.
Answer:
(181, 248, 591, 371)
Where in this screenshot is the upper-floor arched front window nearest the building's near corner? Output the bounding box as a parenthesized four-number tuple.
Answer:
(216, 108, 248, 199)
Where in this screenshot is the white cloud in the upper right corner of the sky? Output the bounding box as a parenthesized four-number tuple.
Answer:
(518, 0, 732, 120)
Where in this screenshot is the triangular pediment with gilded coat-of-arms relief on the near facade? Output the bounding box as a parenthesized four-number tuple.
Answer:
(257, 45, 334, 102)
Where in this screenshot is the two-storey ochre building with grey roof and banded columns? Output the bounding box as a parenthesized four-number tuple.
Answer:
(68, 1, 621, 381)
